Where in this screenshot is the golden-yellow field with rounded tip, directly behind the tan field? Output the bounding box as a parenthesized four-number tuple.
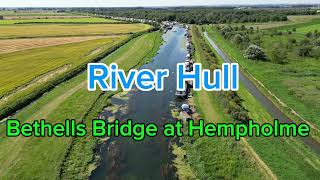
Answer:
(0, 24, 150, 39)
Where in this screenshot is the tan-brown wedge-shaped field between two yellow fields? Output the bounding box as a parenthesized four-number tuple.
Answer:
(0, 36, 116, 54)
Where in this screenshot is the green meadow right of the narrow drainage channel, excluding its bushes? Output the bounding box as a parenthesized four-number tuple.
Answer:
(207, 24, 320, 132)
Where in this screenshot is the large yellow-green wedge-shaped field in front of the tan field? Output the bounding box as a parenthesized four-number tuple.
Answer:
(0, 36, 127, 101)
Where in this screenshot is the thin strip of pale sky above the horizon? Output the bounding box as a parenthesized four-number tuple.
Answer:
(0, 0, 320, 7)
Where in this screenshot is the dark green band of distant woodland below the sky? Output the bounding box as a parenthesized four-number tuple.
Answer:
(73, 7, 317, 24)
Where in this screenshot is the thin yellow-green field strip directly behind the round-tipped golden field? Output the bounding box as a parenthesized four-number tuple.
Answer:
(0, 16, 120, 25)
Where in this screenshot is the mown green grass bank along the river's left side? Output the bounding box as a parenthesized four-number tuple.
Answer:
(0, 32, 161, 179)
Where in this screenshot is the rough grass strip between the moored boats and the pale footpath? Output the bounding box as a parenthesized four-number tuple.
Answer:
(182, 27, 268, 179)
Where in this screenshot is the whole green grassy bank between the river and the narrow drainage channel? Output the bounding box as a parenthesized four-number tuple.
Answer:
(185, 24, 320, 179)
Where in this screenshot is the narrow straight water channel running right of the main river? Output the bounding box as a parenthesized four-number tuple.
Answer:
(204, 32, 320, 153)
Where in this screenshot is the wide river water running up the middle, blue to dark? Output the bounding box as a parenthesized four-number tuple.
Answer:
(90, 26, 187, 180)
